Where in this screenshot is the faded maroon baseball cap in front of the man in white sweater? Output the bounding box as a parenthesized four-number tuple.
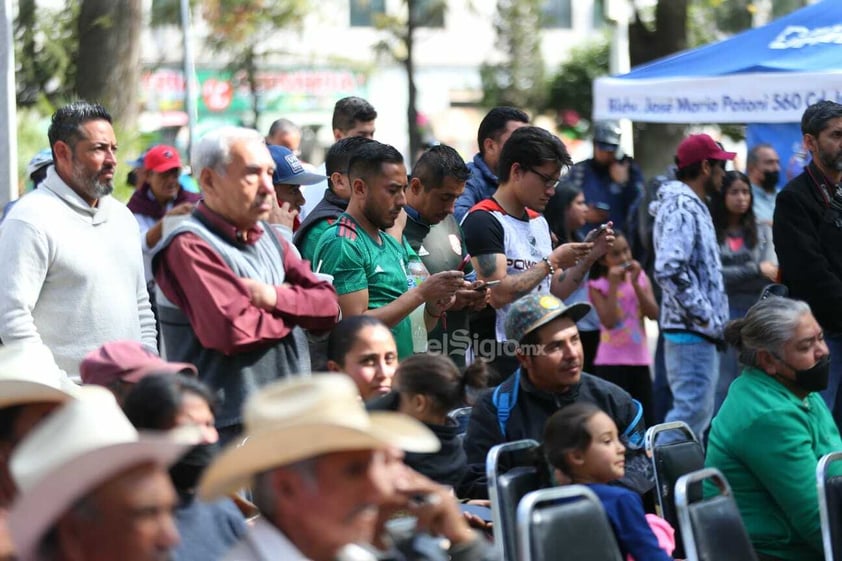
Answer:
(79, 341, 198, 386)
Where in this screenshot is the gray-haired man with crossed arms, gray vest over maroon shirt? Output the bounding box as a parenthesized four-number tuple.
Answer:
(153, 127, 339, 440)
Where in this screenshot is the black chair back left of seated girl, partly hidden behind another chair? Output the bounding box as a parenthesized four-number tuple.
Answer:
(485, 439, 541, 561)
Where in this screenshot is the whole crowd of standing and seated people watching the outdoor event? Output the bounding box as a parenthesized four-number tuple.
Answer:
(0, 98, 842, 561)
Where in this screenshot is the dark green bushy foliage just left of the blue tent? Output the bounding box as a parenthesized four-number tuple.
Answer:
(545, 38, 611, 131)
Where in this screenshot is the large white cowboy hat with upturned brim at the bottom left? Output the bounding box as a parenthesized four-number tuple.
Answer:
(9, 386, 198, 561)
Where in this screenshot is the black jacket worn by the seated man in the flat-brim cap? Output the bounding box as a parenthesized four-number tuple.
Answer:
(457, 372, 654, 499)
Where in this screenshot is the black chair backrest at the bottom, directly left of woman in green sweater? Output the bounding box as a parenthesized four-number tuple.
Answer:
(675, 468, 757, 561)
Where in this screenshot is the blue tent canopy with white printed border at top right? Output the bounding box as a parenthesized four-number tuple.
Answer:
(594, 0, 842, 123)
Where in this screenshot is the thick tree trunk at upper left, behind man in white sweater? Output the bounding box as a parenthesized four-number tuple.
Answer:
(76, 0, 143, 130)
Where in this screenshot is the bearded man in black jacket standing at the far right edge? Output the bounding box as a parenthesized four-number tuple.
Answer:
(772, 101, 842, 427)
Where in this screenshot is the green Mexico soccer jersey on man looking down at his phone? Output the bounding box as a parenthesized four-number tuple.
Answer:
(313, 214, 412, 359)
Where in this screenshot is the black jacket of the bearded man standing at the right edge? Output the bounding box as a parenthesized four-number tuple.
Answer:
(772, 162, 842, 333)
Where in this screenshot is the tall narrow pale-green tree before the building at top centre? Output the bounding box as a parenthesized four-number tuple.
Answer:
(480, 0, 547, 110)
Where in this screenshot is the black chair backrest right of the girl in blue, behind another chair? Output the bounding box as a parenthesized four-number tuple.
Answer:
(644, 421, 705, 558)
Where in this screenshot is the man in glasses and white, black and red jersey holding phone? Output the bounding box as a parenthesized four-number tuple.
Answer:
(462, 126, 614, 382)
